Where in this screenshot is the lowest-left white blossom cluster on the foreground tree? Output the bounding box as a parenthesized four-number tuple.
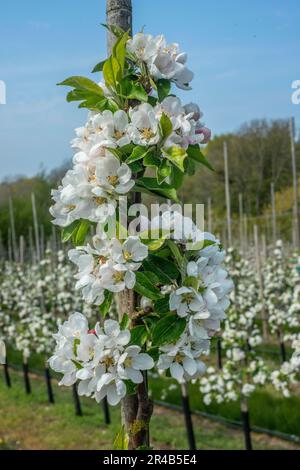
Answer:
(49, 312, 154, 405)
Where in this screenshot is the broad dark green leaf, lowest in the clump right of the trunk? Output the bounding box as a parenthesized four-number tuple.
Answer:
(152, 313, 186, 347)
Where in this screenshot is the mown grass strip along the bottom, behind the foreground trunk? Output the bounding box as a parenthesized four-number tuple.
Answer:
(0, 371, 298, 450)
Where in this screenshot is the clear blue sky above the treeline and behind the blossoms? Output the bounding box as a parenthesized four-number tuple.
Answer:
(0, 0, 300, 179)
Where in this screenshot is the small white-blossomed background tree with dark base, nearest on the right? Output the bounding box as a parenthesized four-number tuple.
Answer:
(200, 248, 269, 450)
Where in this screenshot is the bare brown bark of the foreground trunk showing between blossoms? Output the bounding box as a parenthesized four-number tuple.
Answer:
(106, 0, 153, 450)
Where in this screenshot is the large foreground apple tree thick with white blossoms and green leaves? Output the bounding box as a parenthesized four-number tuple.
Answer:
(50, 1, 232, 449)
